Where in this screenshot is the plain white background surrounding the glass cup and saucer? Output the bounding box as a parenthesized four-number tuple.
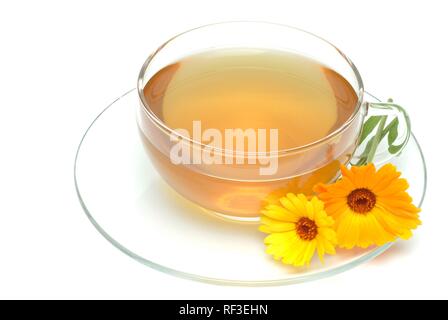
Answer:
(0, 0, 448, 299)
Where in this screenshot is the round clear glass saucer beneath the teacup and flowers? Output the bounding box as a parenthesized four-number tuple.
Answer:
(74, 89, 426, 286)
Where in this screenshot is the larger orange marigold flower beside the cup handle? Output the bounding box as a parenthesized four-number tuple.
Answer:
(314, 163, 421, 249)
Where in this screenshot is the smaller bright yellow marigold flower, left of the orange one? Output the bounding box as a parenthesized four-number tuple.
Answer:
(260, 193, 336, 266)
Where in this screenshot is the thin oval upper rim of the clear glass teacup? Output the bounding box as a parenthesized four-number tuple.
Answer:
(137, 20, 364, 157)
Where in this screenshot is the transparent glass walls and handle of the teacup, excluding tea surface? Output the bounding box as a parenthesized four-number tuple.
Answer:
(137, 22, 410, 220)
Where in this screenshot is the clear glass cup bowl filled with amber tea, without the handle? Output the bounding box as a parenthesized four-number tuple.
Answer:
(138, 22, 400, 219)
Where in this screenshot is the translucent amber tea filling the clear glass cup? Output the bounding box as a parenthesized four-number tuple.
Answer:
(139, 49, 359, 217)
